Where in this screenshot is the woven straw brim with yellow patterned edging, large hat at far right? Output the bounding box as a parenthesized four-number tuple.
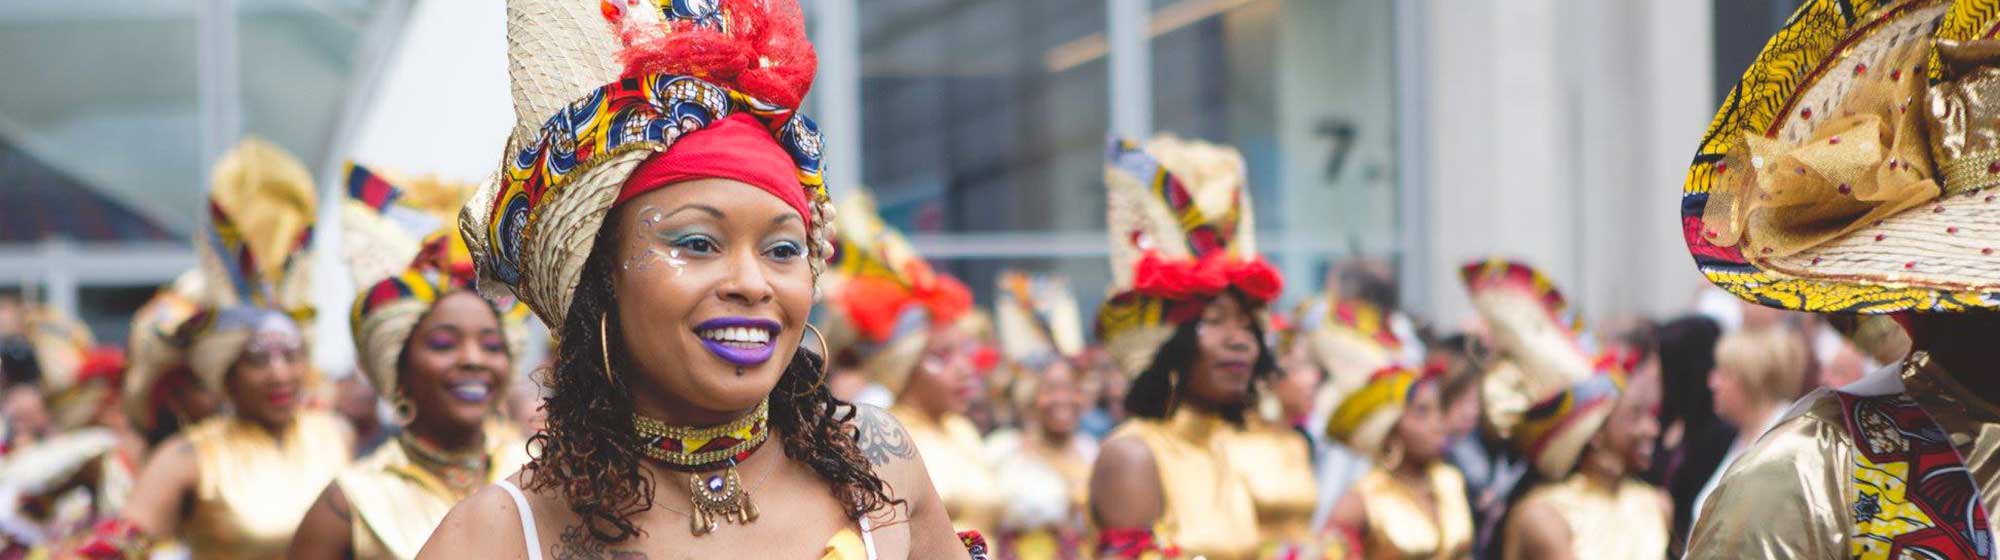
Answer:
(1680, 0, 2000, 314)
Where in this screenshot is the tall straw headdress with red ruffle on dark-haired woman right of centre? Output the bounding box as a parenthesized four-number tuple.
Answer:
(1096, 136, 1284, 376)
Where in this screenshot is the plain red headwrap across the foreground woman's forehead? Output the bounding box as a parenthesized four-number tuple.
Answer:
(614, 112, 812, 228)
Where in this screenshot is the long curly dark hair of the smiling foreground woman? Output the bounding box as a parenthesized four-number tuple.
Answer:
(524, 214, 906, 544)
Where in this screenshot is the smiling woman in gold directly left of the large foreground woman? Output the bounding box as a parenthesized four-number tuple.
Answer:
(290, 166, 528, 558)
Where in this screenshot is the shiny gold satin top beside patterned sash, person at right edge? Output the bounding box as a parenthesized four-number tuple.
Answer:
(1688, 360, 2000, 558)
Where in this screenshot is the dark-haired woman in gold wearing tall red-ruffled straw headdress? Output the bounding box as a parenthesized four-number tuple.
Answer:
(1090, 136, 1312, 558)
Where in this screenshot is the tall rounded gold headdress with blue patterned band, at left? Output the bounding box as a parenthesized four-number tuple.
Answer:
(180, 138, 318, 390)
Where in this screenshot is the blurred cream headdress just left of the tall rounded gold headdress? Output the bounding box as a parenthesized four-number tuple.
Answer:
(124, 270, 204, 430)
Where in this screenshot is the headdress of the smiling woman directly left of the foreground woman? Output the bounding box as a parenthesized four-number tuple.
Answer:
(340, 164, 528, 396)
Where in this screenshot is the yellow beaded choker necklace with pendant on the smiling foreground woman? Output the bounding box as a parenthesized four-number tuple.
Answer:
(632, 398, 770, 536)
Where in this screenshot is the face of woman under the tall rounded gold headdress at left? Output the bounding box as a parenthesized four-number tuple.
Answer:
(224, 318, 306, 426)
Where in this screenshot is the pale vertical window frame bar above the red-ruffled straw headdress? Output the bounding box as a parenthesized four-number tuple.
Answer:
(1104, 0, 1152, 138)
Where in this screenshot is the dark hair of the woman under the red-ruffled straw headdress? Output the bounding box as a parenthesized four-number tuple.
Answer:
(1124, 288, 1278, 426)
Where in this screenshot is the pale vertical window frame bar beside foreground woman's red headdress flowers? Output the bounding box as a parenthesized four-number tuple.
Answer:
(812, 0, 864, 196)
